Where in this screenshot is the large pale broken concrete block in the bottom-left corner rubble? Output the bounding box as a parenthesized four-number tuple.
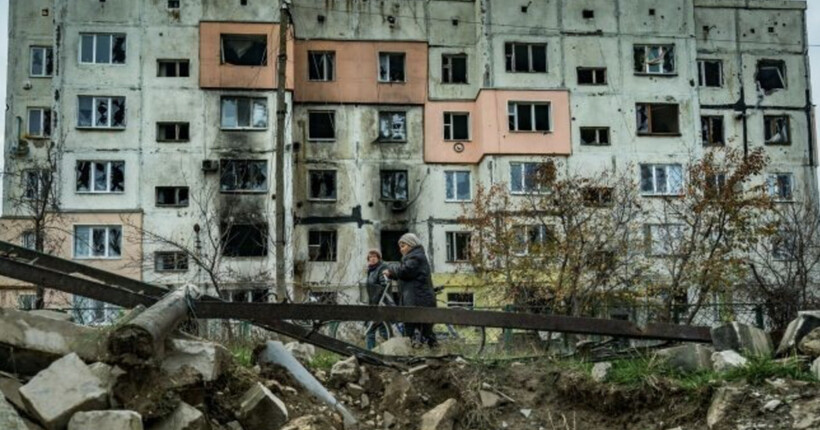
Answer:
(20, 353, 108, 430)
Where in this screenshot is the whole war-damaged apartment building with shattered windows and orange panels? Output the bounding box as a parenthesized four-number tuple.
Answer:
(3, 0, 817, 316)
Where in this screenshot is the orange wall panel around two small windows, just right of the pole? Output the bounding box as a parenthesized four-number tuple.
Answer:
(294, 40, 427, 104)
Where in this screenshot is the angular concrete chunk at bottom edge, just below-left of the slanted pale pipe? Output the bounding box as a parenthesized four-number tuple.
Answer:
(237, 382, 288, 430)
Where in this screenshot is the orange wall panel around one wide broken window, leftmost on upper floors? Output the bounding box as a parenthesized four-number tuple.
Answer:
(199, 22, 293, 90)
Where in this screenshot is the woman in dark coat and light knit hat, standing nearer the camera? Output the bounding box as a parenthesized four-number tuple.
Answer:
(384, 233, 438, 347)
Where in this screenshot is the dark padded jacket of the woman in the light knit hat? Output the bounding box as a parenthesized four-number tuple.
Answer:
(389, 246, 436, 308)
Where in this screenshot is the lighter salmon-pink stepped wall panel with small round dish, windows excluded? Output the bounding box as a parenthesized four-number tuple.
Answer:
(424, 89, 572, 163)
